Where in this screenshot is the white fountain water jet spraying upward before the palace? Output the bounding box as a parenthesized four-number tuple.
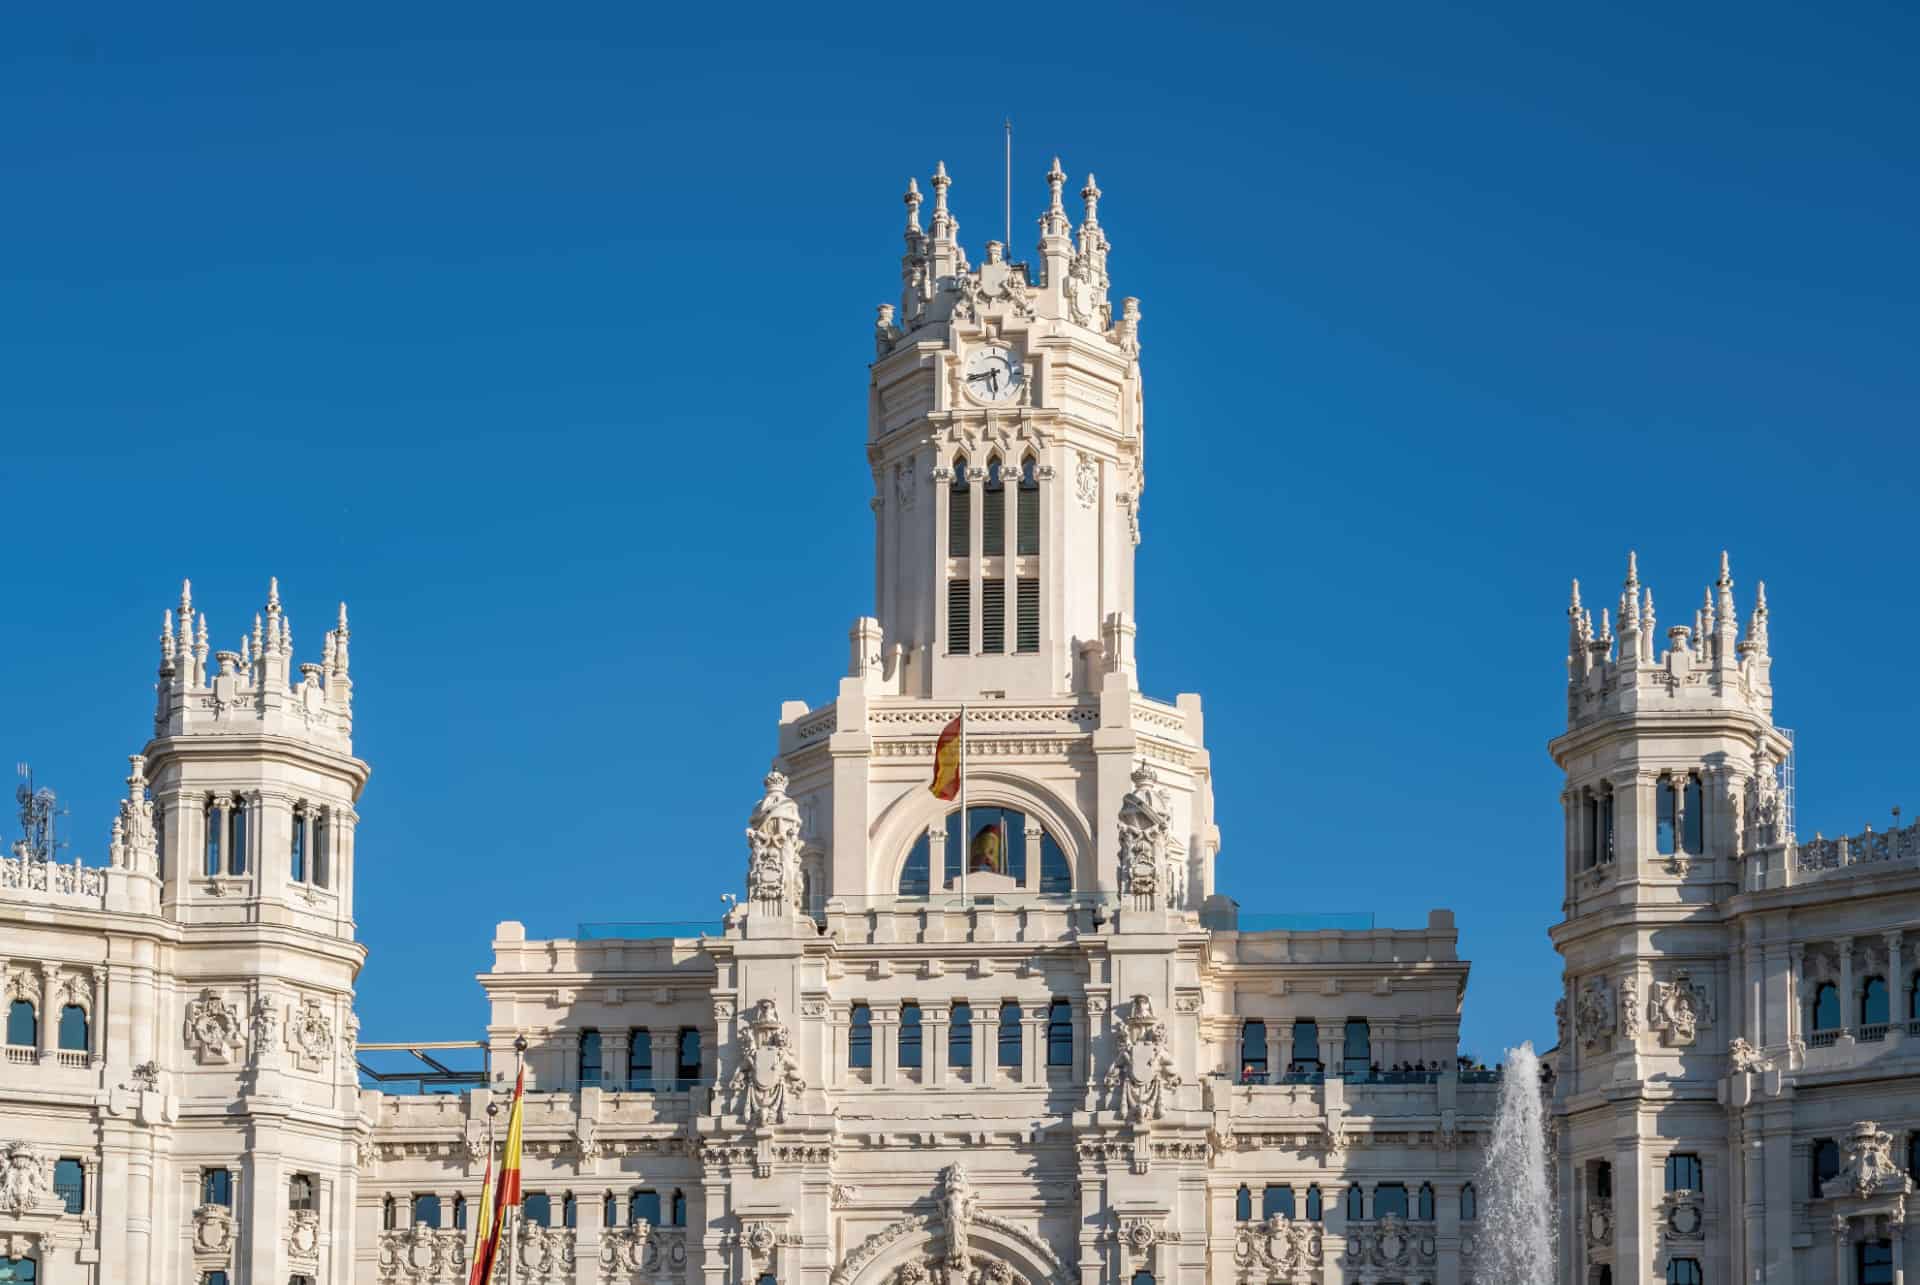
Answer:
(1475, 1043, 1555, 1285)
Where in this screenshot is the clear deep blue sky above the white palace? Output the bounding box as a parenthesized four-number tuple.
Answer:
(0, 2, 1920, 1058)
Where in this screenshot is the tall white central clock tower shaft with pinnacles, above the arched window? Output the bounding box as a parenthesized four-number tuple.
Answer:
(868, 159, 1144, 699)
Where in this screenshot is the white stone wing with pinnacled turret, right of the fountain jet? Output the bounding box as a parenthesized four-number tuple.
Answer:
(1551, 555, 1920, 1285)
